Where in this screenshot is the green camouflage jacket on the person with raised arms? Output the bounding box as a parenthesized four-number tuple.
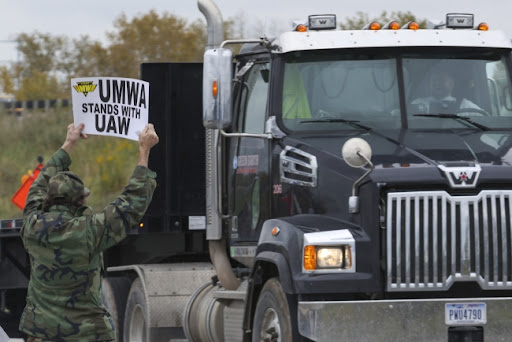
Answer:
(20, 149, 156, 342)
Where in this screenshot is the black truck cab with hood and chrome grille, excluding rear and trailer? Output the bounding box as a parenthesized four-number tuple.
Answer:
(203, 14, 512, 341)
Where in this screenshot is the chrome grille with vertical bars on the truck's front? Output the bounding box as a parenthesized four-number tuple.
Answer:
(386, 190, 512, 291)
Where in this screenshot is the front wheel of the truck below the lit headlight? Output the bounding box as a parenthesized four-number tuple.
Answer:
(252, 278, 293, 342)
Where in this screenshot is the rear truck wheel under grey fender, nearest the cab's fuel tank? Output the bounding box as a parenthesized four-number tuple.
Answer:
(123, 278, 149, 342)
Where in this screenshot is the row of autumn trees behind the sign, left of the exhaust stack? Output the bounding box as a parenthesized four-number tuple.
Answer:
(0, 10, 233, 100)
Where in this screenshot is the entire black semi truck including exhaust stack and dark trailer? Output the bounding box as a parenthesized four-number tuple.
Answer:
(0, 0, 512, 341)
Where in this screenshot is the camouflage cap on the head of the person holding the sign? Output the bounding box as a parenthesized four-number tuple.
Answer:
(46, 171, 91, 203)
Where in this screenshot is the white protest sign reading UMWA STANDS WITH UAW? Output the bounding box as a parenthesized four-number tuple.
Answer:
(71, 77, 149, 141)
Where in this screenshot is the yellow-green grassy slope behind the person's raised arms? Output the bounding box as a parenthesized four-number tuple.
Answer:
(0, 109, 138, 219)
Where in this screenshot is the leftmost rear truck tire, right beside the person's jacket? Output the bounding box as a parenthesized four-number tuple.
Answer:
(101, 277, 132, 342)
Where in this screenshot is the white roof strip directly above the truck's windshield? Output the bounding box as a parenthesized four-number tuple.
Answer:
(272, 29, 512, 53)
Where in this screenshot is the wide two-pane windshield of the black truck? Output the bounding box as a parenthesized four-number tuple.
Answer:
(279, 48, 512, 131)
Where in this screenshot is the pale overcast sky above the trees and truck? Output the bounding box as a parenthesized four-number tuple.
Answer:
(0, 0, 512, 64)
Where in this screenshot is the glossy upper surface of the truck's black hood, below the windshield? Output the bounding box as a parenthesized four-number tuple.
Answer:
(296, 130, 512, 167)
